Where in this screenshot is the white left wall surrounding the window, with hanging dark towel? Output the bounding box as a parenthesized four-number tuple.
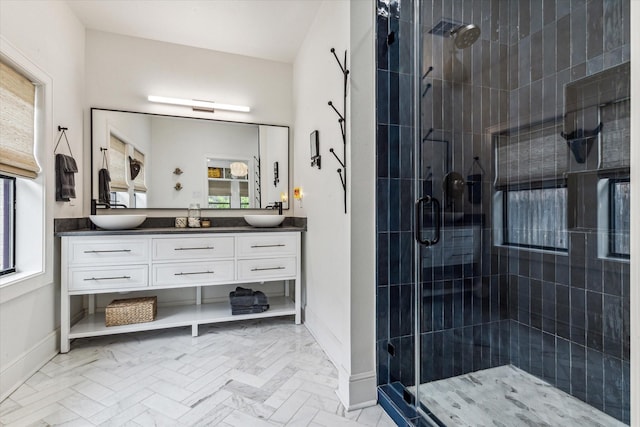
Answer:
(0, 0, 85, 400)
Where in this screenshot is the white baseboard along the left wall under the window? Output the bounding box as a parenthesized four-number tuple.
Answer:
(0, 329, 60, 402)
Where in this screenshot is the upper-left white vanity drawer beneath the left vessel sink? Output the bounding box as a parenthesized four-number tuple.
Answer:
(68, 237, 149, 265)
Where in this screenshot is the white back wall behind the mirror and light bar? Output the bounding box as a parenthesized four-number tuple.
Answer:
(84, 30, 293, 217)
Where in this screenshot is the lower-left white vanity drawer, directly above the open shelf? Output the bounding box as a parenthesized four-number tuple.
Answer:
(69, 265, 149, 291)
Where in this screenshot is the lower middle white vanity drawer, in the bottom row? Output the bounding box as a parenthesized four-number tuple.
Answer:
(153, 261, 234, 286)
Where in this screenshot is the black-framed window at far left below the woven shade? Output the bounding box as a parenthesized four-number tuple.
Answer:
(0, 175, 16, 275)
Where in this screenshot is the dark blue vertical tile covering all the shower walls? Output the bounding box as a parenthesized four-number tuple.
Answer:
(376, 0, 630, 422)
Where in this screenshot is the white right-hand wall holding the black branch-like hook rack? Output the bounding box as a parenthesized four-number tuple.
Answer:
(292, 1, 351, 406)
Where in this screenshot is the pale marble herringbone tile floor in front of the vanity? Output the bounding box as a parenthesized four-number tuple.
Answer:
(0, 319, 395, 427)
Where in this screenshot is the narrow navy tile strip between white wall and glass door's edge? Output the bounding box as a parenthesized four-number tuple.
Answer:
(376, 1, 415, 385)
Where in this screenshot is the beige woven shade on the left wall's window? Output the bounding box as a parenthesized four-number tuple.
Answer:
(0, 62, 40, 178)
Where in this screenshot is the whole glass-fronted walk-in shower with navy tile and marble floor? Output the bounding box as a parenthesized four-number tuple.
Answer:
(376, 0, 630, 426)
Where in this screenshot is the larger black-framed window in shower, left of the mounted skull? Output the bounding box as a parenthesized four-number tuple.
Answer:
(502, 187, 568, 251)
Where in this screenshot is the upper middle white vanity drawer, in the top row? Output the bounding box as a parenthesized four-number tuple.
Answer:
(153, 236, 234, 261)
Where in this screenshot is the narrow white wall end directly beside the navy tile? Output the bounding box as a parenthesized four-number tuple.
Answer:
(339, 1, 377, 408)
